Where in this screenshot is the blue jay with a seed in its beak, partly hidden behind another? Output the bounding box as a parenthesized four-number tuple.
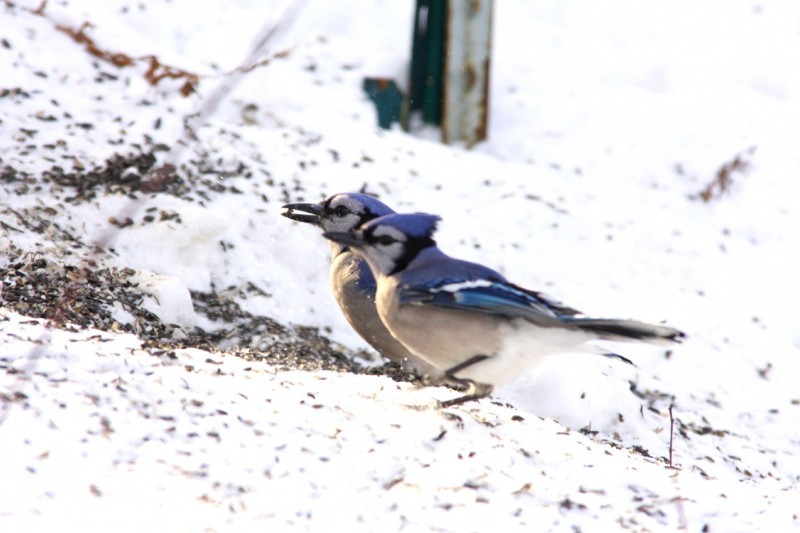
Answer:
(282, 193, 430, 374)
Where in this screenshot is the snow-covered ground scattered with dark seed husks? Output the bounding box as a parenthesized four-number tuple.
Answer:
(0, 0, 800, 531)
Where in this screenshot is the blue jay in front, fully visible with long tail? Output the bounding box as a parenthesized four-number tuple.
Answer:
(324, 214, 684, 406)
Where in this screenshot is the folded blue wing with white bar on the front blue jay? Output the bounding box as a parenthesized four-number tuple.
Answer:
(399, 279, 578, 321)
